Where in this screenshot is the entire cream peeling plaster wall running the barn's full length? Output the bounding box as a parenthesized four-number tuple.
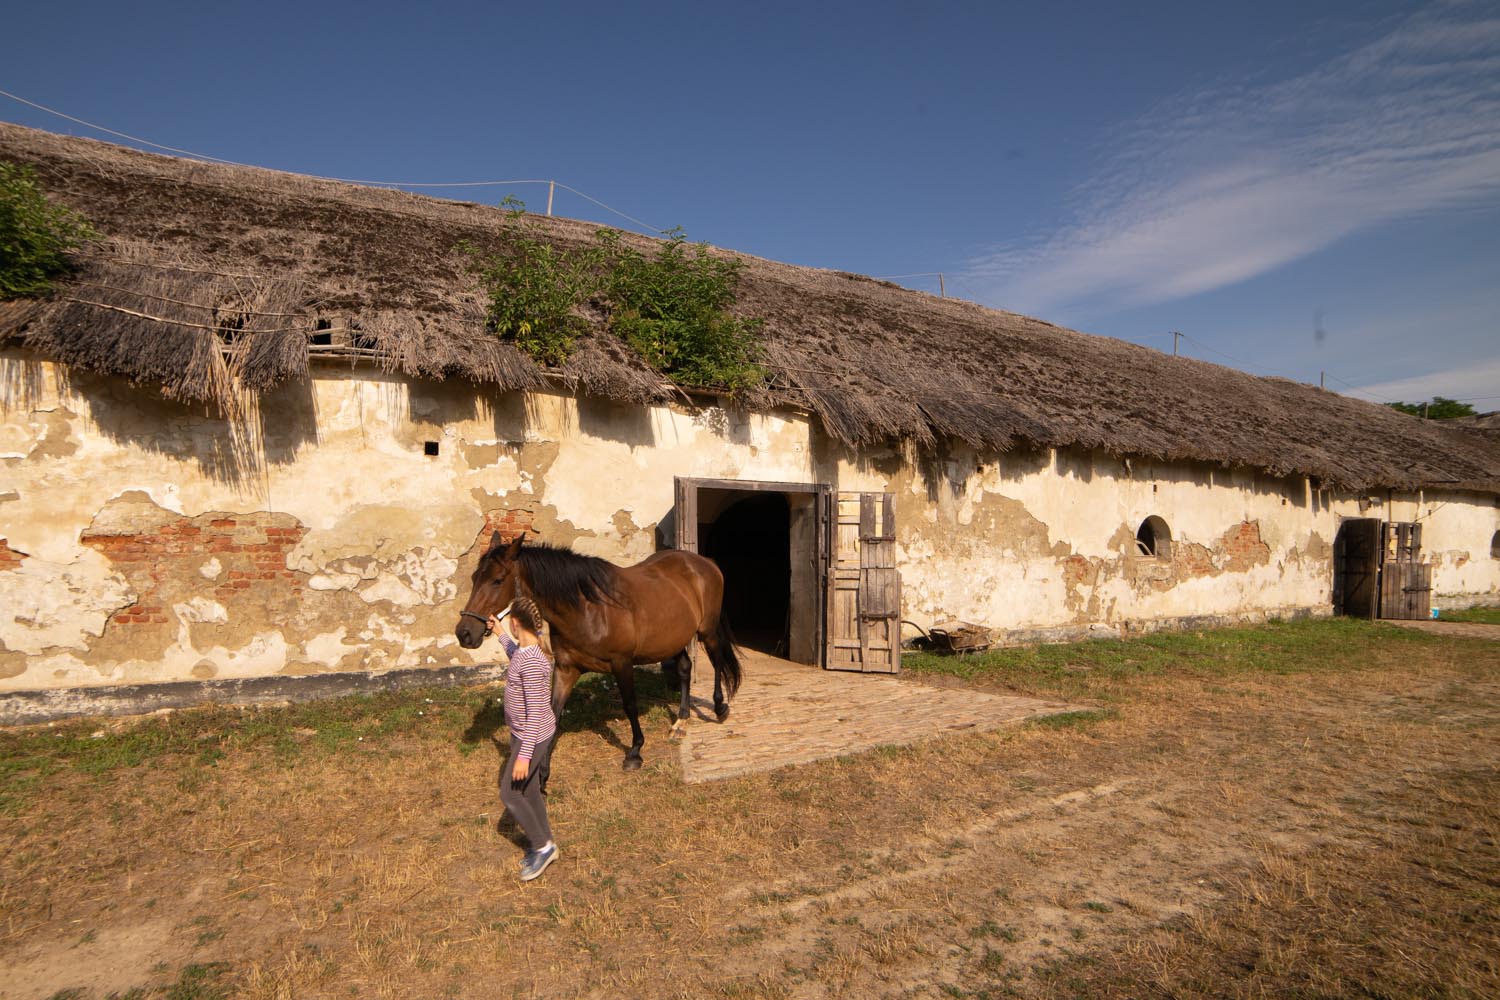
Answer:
(0, 352, 1500, 691)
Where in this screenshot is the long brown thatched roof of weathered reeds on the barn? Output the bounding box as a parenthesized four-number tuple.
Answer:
(0, 123, 1500, 493)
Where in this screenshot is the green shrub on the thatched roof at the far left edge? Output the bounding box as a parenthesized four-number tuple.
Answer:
(0, 162, 98, 300)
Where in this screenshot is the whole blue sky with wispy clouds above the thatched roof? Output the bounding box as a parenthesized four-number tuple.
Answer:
(0, 0, 1500, 411)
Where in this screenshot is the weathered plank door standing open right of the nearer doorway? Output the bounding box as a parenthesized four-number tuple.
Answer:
(824, 493, 902, 673)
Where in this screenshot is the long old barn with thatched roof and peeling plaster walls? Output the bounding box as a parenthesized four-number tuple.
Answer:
(0, 124, 1500, 703)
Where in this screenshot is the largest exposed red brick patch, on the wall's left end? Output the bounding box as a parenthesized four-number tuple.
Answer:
(81, 511, 308, 625)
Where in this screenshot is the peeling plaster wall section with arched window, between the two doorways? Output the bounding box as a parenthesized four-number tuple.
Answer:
(840, 448, 1362, 630)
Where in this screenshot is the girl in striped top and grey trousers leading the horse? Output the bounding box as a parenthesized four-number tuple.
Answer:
(489, 597, 558, 882)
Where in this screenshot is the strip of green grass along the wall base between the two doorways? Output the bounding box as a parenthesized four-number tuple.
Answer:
(902, 618, 1433, 704)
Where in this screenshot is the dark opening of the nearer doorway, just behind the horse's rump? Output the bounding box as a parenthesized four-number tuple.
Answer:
(699, 490, 792, 657)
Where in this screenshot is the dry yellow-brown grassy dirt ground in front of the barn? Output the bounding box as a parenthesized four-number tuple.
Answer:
(0, 622, 1500, 1000)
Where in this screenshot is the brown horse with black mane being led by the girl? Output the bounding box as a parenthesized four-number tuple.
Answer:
(455, 532, 740, 771)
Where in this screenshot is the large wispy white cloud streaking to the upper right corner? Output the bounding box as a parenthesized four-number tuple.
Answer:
(963, 3, 1500, 312)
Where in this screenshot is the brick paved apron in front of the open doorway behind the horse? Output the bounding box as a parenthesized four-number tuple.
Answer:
(681, 649, 1070, 783)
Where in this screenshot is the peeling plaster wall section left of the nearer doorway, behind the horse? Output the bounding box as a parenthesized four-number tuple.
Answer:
(0, 352, 813, 691)
